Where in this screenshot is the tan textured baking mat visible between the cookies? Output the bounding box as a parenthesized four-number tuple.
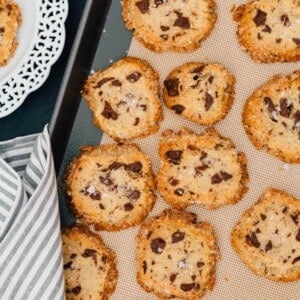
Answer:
(101, 0, 300, 300)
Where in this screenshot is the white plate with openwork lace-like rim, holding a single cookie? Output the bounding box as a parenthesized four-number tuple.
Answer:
(0, 0, 68, 118)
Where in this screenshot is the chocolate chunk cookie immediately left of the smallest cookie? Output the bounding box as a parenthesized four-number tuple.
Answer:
(83, 57, 162, 141)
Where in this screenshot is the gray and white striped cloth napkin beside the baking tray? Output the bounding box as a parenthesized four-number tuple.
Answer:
(0, 127, 65, 300)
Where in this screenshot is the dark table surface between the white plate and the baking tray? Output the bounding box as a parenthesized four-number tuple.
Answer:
(0, 0, 86, 141)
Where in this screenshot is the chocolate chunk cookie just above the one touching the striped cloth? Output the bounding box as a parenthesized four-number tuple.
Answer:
(63, 144, 155, 231)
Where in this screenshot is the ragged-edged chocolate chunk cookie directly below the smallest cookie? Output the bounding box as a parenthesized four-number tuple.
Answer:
(157, 128, 248, 209)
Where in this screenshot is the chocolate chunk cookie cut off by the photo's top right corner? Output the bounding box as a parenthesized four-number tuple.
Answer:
(232, 0, 300, 63)
